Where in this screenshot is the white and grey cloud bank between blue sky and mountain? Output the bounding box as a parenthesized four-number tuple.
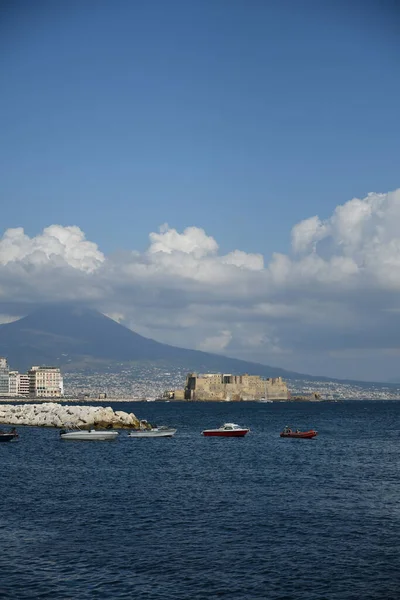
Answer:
(0, 189, 400, 379)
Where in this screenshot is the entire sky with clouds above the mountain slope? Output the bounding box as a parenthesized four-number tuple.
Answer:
(0, 0, 400, 381)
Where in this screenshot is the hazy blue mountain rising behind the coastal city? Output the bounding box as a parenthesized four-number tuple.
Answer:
(0, 305, 311, 379)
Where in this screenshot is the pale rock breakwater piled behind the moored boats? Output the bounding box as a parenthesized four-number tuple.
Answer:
(0, 402, 139, 429)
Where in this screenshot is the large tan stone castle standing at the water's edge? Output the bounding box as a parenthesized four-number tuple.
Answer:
(172, 373, 290, 401)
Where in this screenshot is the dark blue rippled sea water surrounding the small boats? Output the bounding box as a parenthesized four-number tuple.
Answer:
(0, 402, 400, 600)
